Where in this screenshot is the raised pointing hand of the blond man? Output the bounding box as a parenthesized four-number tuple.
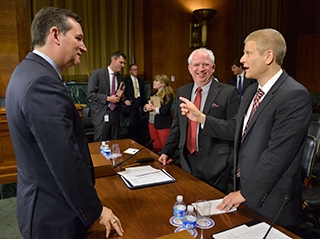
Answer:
(179, 96, 206, 124)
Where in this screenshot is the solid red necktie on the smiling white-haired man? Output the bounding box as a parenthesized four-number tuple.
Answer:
(187, 87, 202, 154)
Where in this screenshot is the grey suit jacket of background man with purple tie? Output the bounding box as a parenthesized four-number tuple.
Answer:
(88, 68, 123, 125)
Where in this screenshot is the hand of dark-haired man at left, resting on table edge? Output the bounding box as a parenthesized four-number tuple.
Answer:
(99, 206, 124, 238)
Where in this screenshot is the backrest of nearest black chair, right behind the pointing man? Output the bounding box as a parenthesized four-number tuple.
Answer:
(301, 134, 318, 187)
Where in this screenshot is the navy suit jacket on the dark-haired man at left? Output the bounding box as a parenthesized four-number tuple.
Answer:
(6, 53, 102, 238)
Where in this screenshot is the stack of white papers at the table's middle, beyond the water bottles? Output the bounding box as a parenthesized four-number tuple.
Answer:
(118, 165, 175, 189)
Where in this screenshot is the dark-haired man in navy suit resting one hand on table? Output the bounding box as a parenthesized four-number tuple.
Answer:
(6, 7, 123, 239)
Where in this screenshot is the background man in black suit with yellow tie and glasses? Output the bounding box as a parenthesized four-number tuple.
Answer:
(123, 64, 147, 145)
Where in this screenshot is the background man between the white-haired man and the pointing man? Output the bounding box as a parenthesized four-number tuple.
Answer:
(228, 59, 257, 99)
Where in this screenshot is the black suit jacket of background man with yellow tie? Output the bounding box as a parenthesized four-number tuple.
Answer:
(124, 76, 147, 116)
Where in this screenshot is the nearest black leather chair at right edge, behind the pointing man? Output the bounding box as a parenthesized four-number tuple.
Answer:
(301, 134, 320, 228)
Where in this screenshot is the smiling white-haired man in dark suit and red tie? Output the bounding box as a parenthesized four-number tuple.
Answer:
(159, 48, 240, 192)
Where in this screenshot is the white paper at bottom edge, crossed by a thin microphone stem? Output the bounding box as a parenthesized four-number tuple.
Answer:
(212, 222, 291, 239)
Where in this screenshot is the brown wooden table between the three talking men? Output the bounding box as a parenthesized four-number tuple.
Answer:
(87, 139, 300, 239)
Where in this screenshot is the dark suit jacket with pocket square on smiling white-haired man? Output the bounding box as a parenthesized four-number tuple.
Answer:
(162, 80, 239, 190)
